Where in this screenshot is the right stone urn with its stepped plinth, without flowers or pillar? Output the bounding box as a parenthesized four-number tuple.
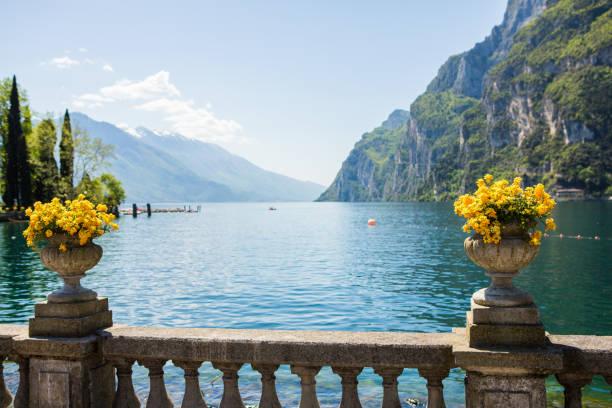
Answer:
(464, 224, 546, 347)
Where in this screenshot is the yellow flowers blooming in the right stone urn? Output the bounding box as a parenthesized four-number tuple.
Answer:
(455, 174, 556, 245)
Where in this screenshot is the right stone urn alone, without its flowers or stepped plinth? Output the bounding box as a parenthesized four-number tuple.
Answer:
(464, 222, 540, 307)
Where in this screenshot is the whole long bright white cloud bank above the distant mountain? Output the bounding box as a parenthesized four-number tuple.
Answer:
(73, 71, 244, 143)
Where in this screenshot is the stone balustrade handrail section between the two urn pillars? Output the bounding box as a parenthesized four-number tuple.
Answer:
(101, 326, 457, 368)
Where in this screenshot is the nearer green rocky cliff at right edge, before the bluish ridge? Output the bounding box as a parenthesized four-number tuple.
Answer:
(483, 0, 612, 192)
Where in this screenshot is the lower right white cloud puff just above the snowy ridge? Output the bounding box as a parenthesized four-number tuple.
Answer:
(136, 98, 242, 142)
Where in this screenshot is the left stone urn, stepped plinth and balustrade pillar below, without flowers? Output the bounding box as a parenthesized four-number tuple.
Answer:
(20, 234, 115, 408)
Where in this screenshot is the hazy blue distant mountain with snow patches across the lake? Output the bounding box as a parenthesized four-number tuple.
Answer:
(71, 112, 324, 202)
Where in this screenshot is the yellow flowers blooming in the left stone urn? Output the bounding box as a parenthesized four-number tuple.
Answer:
(23, 194, 119, 252)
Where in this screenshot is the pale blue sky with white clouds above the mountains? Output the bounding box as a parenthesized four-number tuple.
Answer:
(0, 0, 506, 185)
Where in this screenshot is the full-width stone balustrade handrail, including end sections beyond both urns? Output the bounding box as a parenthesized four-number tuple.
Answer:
(0, 324, 612, 373)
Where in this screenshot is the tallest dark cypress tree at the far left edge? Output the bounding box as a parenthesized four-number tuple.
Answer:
(2, 75, 23, 207)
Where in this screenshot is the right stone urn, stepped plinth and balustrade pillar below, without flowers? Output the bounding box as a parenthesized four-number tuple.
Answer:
(453, 224, 563, 408)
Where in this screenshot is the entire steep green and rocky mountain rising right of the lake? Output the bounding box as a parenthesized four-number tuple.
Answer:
(319, 0, 612, 201)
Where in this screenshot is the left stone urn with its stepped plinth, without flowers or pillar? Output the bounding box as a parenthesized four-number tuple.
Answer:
(29, 234, 113, 337)
